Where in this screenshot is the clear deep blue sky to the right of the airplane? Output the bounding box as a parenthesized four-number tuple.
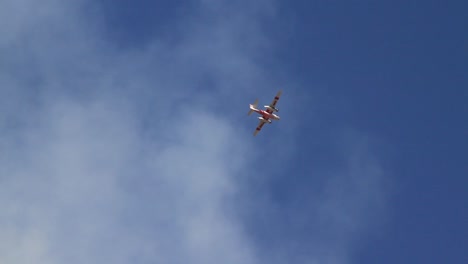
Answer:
(270, 1, 468, 263)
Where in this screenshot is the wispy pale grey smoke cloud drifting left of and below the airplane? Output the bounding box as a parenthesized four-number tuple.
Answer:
(0, 0, 388, 264)
